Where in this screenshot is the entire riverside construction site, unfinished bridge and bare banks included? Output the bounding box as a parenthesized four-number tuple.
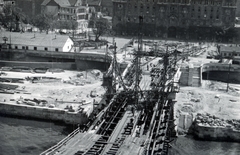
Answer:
(0, 18, 240, 155)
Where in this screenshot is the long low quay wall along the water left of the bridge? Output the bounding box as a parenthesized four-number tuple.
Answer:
(0, 102, 88, 124)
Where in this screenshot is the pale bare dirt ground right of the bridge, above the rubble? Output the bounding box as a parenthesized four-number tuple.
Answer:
(175, 81, 240, 119)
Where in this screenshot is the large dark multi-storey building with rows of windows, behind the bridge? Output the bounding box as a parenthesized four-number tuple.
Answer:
(112, 0, 237, 39)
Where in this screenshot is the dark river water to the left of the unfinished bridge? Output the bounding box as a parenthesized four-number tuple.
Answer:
(0, 116, 73, 155)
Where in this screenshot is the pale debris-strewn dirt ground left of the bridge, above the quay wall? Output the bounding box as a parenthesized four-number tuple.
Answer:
(0, 70, 105, 114)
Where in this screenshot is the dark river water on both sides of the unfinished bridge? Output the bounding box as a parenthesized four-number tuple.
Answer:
(0, 116, 240, 155)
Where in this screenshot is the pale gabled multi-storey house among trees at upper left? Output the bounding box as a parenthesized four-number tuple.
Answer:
(42, 0, 94, 32)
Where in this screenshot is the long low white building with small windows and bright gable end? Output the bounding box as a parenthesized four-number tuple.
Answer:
(0, 32, 74, 52)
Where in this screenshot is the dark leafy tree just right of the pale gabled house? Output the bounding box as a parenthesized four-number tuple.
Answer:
(89, 18, 111, 41)
